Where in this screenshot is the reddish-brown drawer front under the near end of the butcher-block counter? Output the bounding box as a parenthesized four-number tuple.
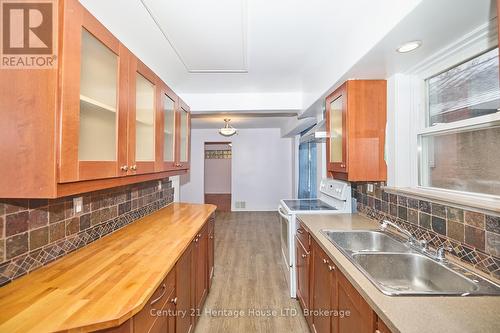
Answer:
(134, 271, 175, 333)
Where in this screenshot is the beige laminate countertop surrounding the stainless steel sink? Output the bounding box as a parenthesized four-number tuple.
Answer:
(299, 214, 500, 333)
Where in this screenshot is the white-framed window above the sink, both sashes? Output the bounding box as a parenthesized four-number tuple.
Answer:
(418, 48, 500, 196)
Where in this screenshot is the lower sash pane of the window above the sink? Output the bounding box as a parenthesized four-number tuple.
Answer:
(420, 125, 500, 195)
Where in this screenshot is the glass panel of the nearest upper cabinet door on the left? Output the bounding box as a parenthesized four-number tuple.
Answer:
(78, 29, 119, 161)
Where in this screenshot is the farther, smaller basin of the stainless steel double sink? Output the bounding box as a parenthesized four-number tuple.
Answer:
(322, 230, 411, 252)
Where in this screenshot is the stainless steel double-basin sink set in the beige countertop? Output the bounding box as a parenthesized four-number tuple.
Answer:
(321, 229, 500, 296)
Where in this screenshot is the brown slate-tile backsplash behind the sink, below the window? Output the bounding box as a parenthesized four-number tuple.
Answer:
(352, 183, 500, 279)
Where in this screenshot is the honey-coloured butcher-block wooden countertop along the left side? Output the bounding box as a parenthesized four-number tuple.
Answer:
(0, 203, 216, 333)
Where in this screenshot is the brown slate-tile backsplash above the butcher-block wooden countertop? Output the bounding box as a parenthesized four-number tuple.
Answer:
(0, 178, 174, 286)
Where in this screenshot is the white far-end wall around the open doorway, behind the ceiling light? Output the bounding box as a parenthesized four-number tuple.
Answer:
(180, 128, 293, 211)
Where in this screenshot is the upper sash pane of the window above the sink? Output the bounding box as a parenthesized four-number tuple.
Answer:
(427, 48, 500, 125)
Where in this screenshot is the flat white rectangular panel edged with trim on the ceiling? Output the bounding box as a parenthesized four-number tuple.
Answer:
(141, 0, 248, 73)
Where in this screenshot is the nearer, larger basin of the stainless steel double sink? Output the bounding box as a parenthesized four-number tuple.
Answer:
(352, 253, 478, 295)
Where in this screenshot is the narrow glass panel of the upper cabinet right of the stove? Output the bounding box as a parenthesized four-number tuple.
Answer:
(330, 96, 344, 163)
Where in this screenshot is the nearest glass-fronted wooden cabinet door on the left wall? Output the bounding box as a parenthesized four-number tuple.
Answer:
(59, 0, 131, 182)
